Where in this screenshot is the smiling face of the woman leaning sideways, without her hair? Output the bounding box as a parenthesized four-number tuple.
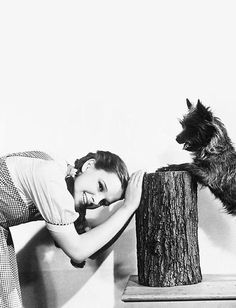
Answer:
(74, 159, 123, 210)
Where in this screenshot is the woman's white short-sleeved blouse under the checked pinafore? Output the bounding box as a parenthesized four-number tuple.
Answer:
(6, 156, 79, 232)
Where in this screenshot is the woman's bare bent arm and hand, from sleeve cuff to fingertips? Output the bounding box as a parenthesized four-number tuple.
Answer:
(50, 171, 144, 263)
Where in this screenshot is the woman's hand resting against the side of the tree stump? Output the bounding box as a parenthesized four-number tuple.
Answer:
(124, 170, 145, 212)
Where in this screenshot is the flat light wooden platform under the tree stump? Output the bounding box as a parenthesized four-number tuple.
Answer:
(122, 275, 236, 302)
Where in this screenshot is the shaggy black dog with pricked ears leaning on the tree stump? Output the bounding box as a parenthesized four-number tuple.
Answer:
(157, 99, 236, 215)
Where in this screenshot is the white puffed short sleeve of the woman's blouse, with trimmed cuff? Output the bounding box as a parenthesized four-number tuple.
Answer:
(29, 161, 79, 230)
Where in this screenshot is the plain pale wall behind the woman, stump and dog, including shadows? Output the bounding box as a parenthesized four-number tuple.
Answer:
(0, 0, 236, 308)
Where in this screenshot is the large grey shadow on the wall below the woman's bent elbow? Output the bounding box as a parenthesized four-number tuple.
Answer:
(17, 228, 109, 308)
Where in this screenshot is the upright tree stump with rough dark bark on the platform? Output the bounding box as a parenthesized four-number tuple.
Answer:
(136, 171, 202, 287)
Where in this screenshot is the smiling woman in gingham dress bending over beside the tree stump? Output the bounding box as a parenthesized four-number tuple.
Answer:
(0, 151, 143, 308)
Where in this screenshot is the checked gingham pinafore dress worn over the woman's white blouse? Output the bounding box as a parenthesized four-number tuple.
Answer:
(0, 151, 52, 308)
